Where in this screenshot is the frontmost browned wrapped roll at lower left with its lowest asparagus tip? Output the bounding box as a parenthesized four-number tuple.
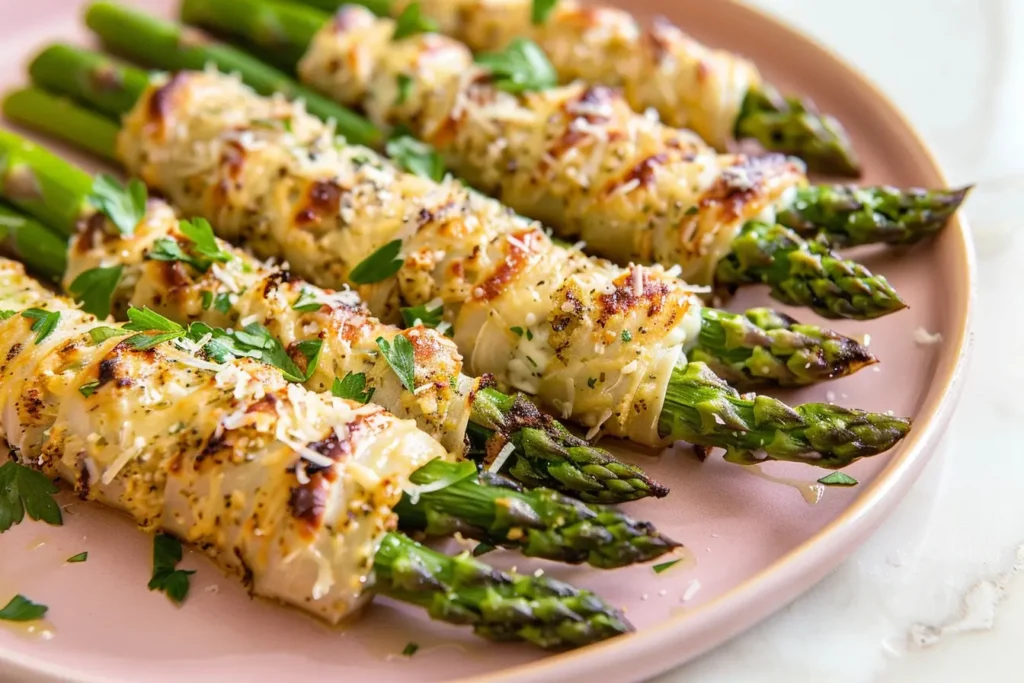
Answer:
(0, 260, 631, 647)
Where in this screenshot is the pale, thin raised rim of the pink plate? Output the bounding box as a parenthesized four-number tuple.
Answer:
(0, 0, 977, 683)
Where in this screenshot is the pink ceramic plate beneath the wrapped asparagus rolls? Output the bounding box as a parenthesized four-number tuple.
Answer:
(0, 0, 972, 683)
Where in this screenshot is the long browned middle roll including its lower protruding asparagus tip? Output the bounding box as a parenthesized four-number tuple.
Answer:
(7, 66, 908, 467)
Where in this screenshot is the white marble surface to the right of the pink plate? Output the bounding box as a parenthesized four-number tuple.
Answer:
(660, 0, 1024, 683)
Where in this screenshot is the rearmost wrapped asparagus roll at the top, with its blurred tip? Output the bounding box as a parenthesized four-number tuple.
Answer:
(294, 0, 860, 175)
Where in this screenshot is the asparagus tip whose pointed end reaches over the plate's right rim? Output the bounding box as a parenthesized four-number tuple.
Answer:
(776, 185, 971, 247)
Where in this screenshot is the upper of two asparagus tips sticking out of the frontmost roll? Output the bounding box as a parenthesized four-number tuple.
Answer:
(395, 461, 679, 569)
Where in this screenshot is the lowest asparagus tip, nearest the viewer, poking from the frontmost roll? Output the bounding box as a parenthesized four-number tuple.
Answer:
(374, 533, 633, 649)
